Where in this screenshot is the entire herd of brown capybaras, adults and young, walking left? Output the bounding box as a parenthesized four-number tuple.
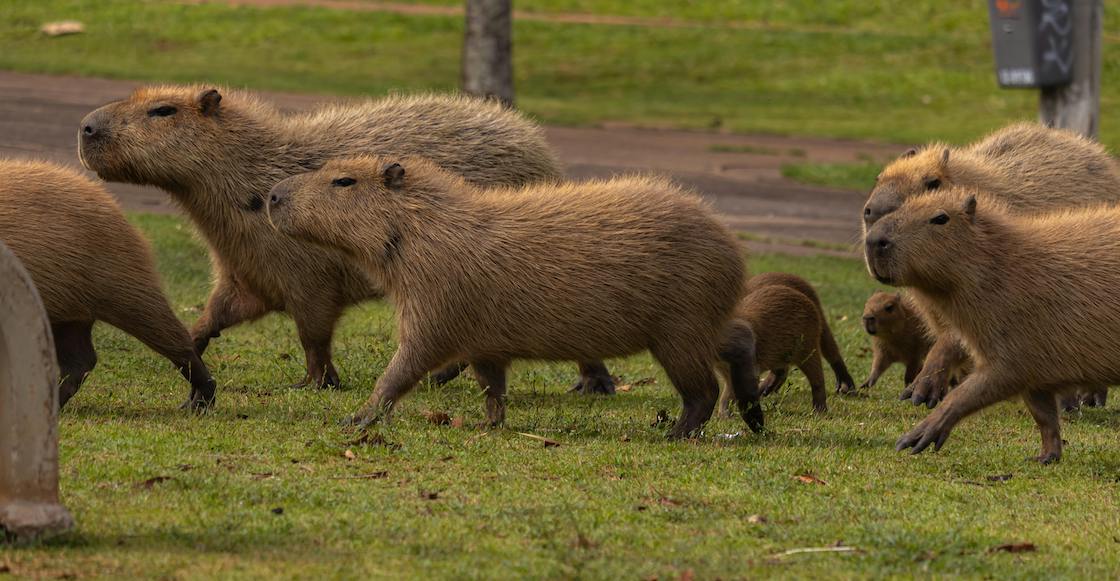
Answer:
(0, 81, 1120, 462)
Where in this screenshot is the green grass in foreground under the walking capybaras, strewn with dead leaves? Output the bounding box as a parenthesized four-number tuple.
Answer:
(0, 216, 1120, 579)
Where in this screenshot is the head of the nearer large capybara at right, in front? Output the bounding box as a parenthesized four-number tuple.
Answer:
(864, 189, 978, 289)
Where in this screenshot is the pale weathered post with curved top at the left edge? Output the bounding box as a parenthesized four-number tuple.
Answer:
(0, 243, 74, 541)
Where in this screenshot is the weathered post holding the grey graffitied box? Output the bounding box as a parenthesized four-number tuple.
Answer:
(1038, 0, 1104, 139)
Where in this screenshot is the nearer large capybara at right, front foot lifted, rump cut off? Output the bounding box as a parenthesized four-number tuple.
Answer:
(865, 188, 1120, 462)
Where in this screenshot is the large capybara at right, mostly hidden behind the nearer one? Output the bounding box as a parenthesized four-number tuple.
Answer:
(864, 123, 1120, 407)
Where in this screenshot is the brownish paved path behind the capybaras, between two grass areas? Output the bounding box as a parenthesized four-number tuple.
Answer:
(0, 72, 899, 252)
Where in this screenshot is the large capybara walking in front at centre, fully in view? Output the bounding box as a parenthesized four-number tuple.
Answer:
(269, 157, 762, 438)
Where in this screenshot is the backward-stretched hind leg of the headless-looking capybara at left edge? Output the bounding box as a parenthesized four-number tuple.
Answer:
(104, 290, 216, 410)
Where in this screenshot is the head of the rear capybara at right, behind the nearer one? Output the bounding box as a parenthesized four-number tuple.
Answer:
(864, 144, 950, 234)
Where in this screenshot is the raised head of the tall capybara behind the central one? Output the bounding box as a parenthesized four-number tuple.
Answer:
(78, 86, 238, 189)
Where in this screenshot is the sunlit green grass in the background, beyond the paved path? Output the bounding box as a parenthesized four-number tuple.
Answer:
(0, 0, 1120, 150)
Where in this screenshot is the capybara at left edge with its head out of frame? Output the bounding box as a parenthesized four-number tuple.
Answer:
(0, 160, 215, 409)
